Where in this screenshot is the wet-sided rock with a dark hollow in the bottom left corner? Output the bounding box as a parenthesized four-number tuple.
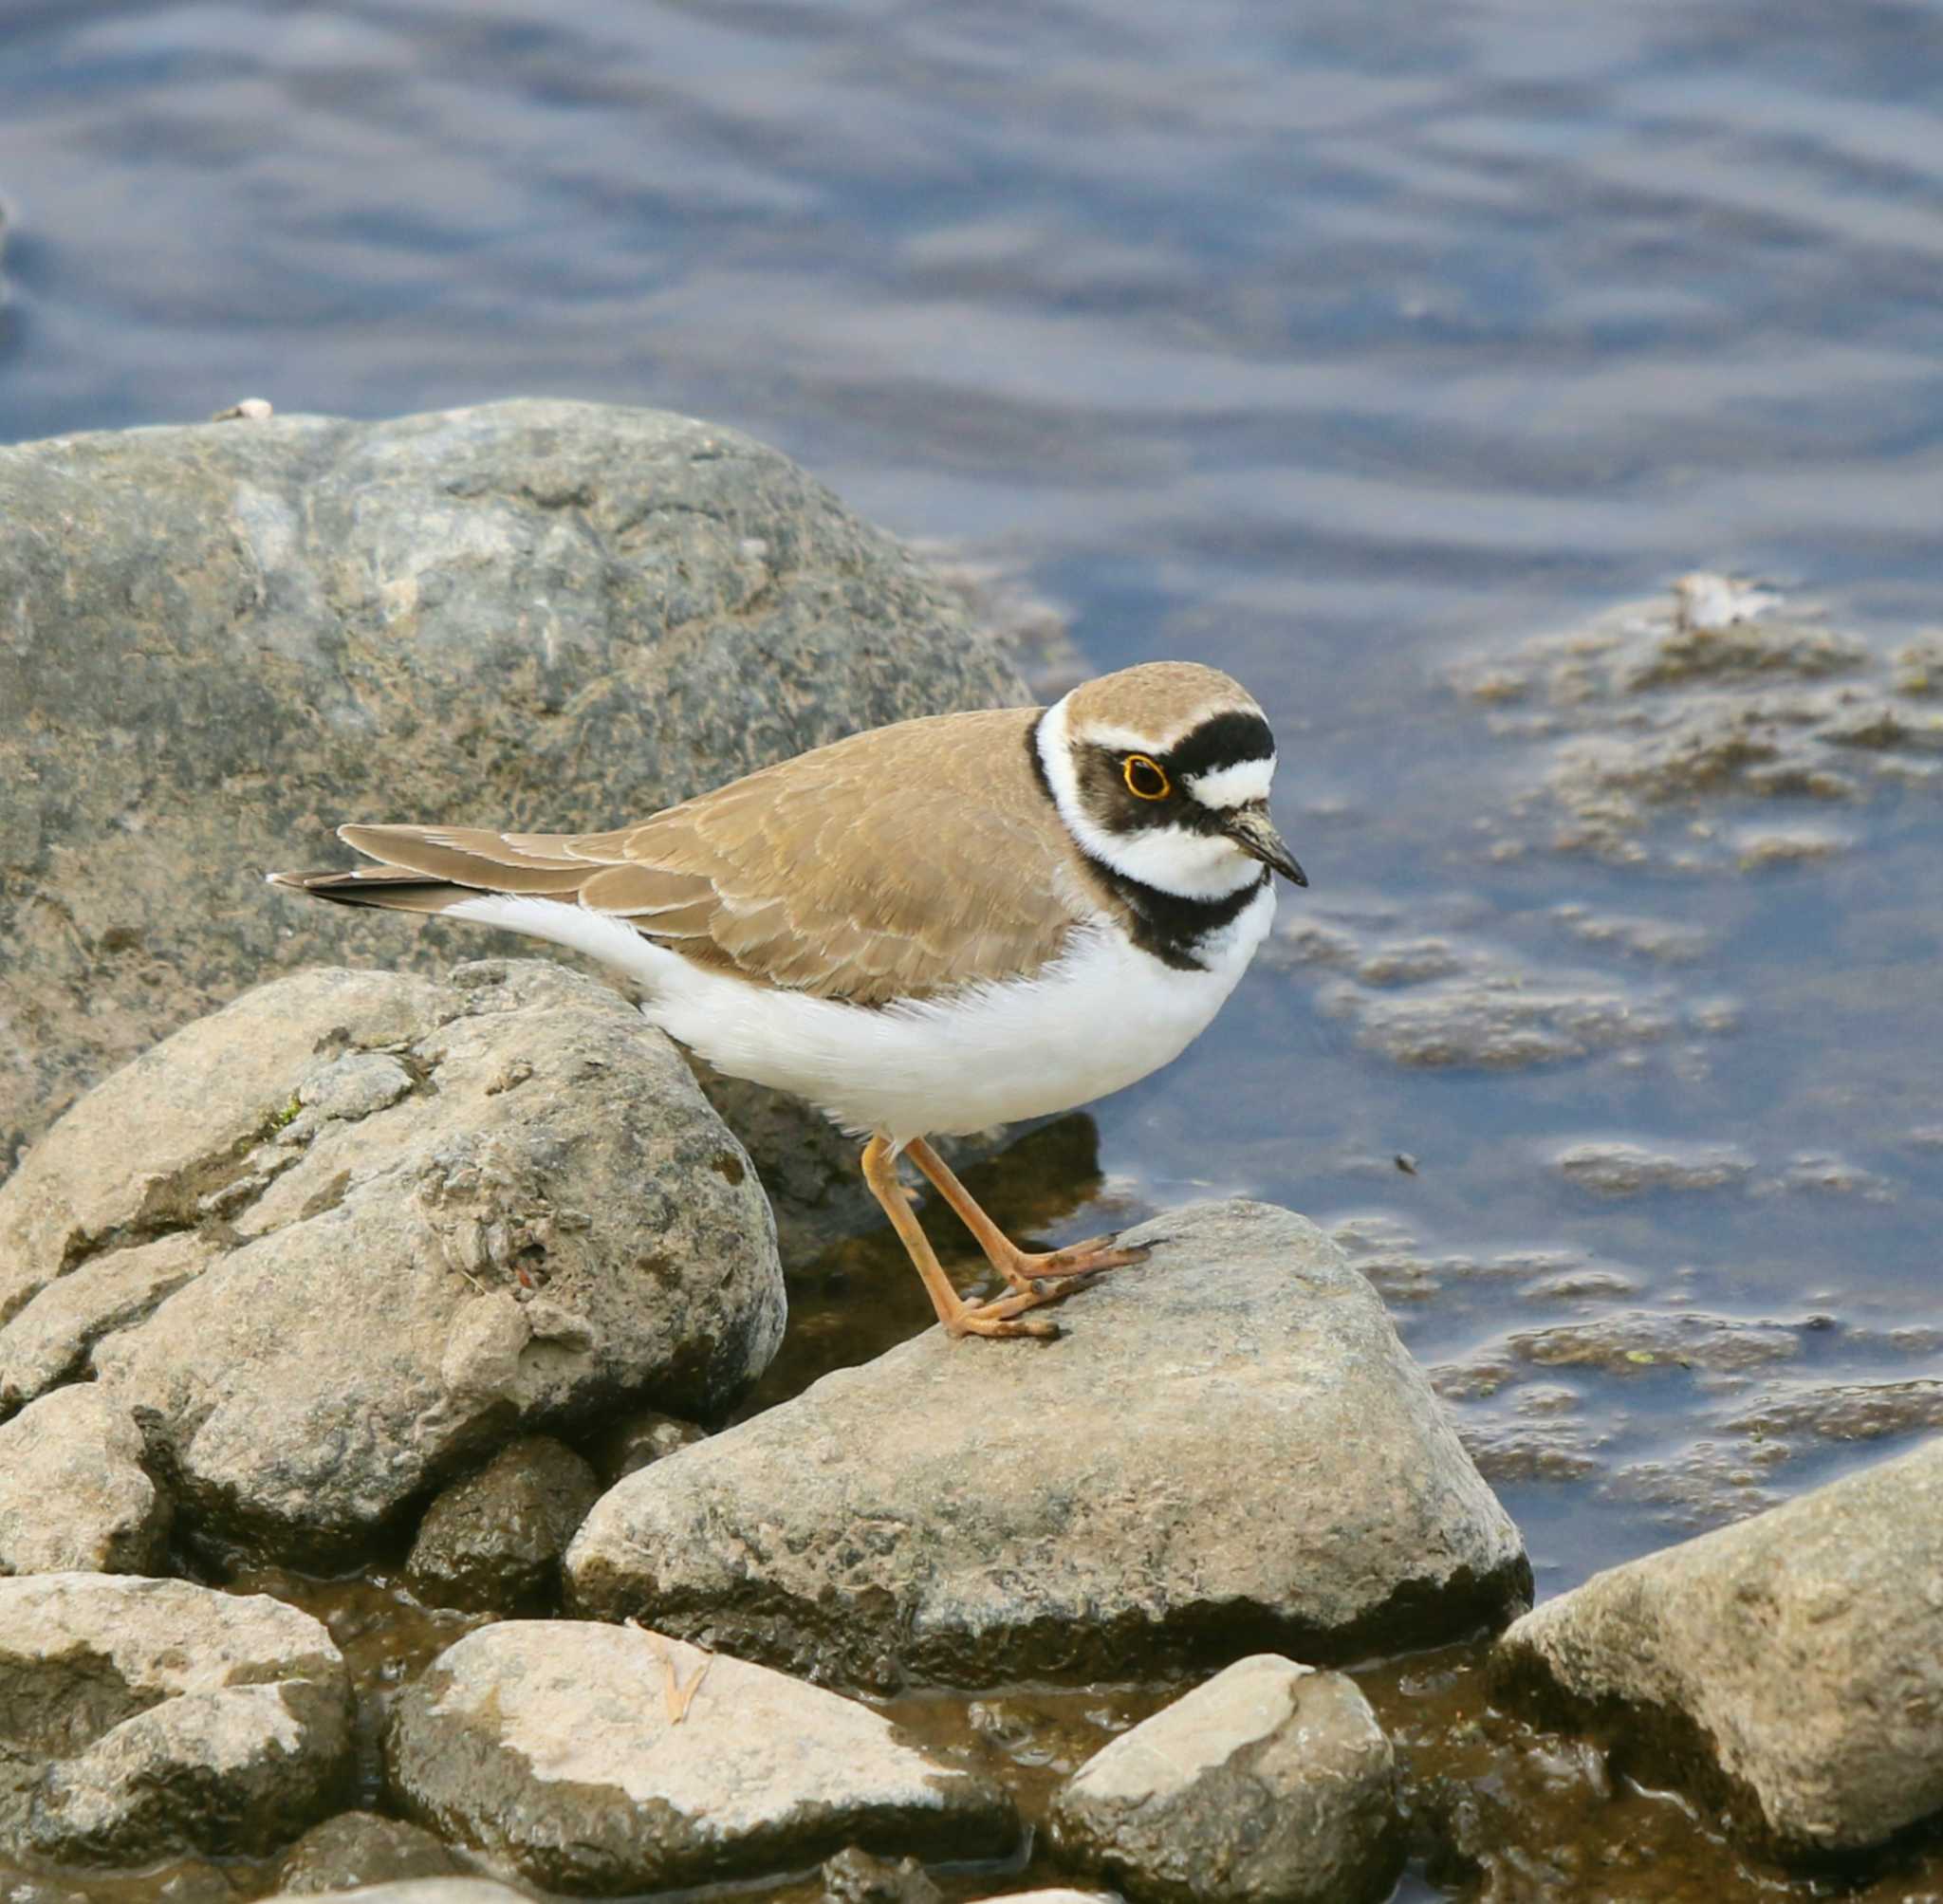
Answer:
(0, 1574, 352, 1865)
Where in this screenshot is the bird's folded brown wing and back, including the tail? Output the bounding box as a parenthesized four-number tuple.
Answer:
(284, 707, 1081, 1005)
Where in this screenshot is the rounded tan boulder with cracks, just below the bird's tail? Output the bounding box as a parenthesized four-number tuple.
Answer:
(0, 960, 785, 1564)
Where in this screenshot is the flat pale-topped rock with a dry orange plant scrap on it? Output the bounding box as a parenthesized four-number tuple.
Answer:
(387, 1620, 1018, 1895)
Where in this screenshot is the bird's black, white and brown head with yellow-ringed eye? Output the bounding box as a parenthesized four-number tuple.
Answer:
(1036, 660, 1307, 899)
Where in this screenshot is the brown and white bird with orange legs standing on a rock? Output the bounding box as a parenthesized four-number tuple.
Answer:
(270, 660, 1307, 1339)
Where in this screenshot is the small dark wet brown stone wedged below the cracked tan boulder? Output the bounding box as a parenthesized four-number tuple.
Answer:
(404, 1433, 601, 1611)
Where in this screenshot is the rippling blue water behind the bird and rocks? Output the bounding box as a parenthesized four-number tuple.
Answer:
(0, 0, 1943, 1895)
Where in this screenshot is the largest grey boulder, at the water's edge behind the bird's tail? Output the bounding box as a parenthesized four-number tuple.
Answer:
(0, 402, 1026, 1175)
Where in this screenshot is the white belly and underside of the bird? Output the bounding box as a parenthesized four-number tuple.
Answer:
(447, 884, 1274, 1140)
